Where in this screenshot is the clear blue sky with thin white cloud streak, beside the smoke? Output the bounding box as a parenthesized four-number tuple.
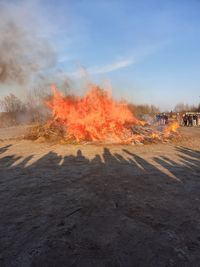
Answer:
(1, 0, 200, 109)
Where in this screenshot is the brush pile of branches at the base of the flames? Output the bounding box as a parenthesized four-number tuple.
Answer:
(25, 120, 180, 145)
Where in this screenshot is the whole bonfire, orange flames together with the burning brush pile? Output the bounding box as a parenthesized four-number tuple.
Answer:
(27, 85, 178, 144)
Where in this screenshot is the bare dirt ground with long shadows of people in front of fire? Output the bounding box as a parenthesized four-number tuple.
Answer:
(0, 128, 200, 267)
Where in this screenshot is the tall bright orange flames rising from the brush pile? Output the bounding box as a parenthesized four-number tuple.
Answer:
(47, 85, 143, 143)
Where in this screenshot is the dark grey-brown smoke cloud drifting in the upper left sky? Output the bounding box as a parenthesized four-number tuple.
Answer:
(0, 1, 55, 84)
